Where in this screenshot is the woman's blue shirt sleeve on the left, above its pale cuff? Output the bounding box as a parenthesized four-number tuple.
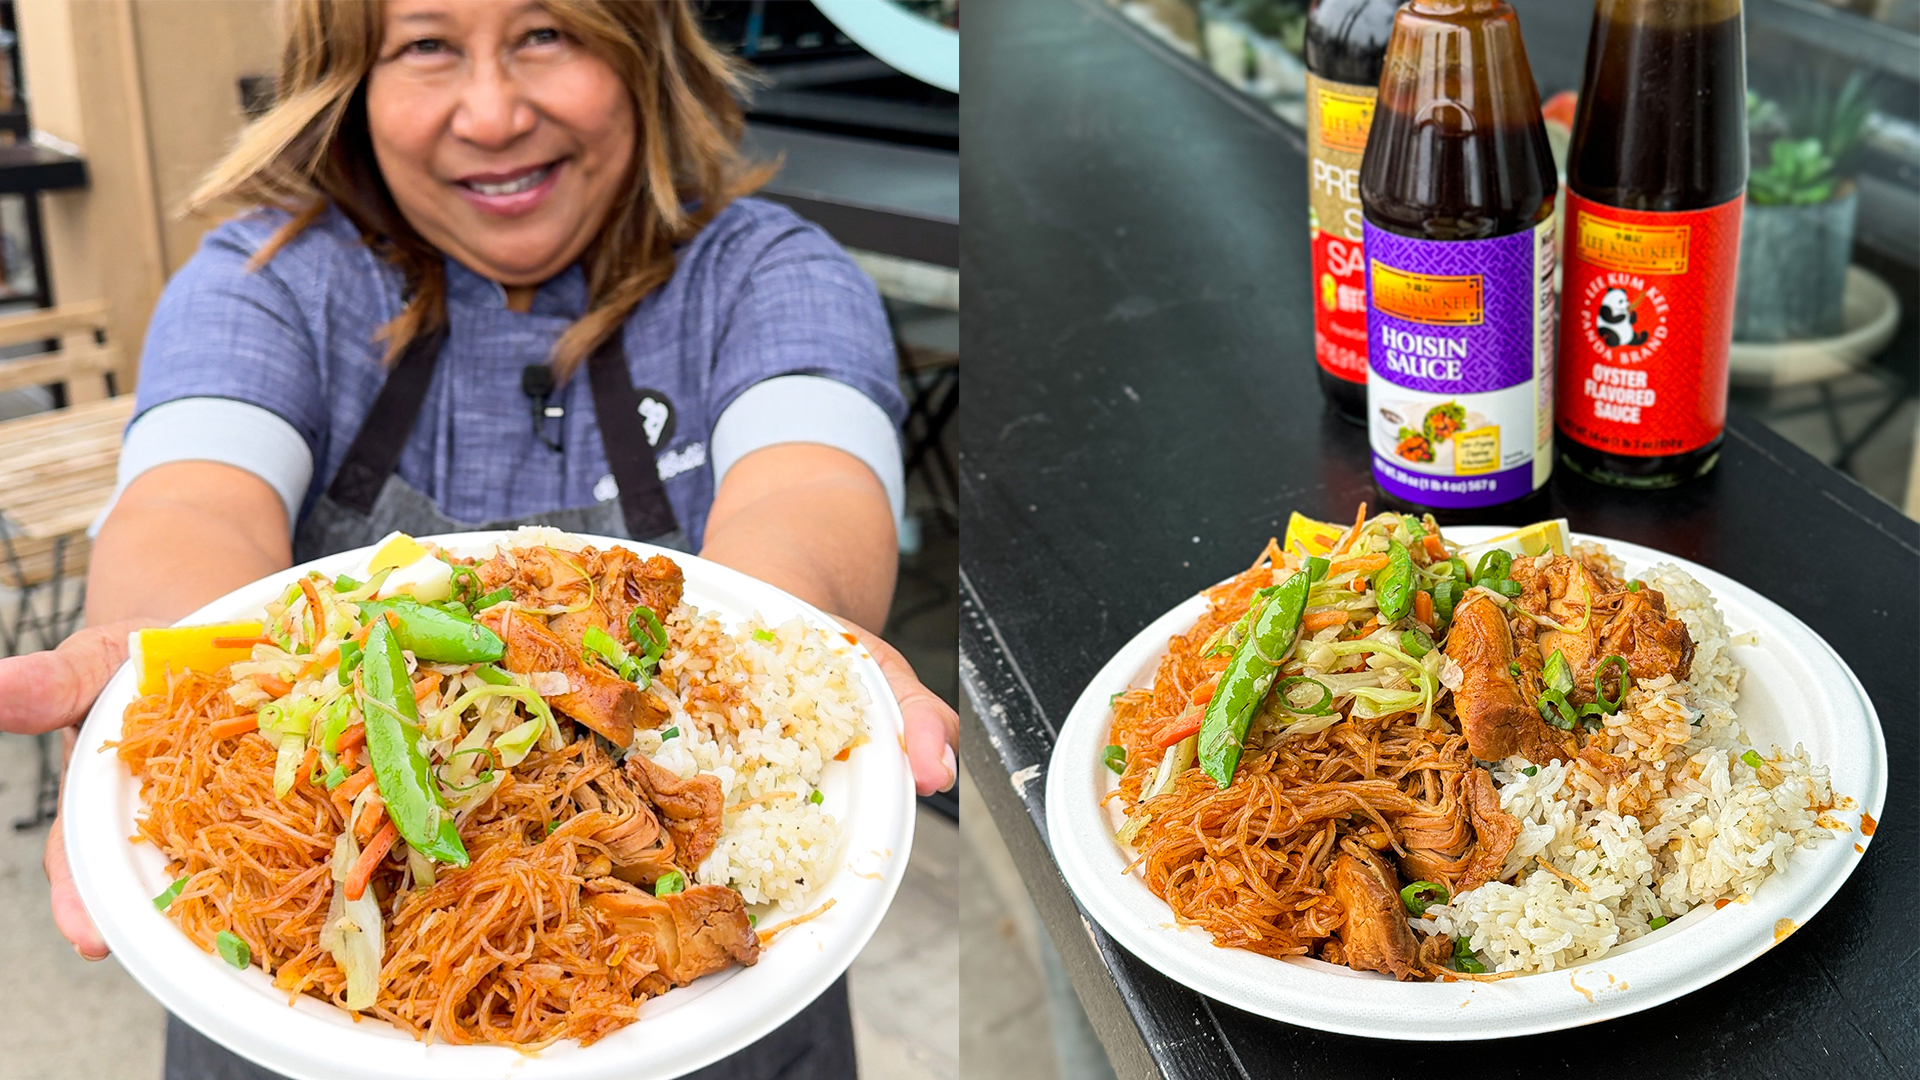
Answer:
(129, 213, 326, 472)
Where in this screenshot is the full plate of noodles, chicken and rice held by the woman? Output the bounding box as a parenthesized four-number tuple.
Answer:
(61, 528, 914, 1080)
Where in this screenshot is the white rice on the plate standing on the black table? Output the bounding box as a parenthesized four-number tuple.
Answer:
(1415, 563, 1834, 972)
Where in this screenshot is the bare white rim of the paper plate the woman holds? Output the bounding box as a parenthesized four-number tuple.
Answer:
(60, 532, 914, 1080)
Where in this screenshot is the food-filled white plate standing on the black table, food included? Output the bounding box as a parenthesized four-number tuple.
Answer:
(1046, 507, 1887, 1040)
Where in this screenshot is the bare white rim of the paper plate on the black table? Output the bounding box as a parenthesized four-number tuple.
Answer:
(1046, 527, 1887, 1042)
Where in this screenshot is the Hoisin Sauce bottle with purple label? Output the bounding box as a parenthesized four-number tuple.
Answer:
(1359, 0, 1557, 509)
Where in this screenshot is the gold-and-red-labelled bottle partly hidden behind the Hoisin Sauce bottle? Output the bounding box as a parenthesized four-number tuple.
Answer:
(1306, 0, 1400, 423)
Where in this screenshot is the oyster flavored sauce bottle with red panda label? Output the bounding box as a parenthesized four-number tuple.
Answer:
(1555, 0, 1747, 488)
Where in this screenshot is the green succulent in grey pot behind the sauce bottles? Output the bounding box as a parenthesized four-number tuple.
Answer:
(1734, 73, 1874, 342)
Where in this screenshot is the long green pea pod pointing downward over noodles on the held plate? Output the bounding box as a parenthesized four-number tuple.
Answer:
(361, 619, 467, 867)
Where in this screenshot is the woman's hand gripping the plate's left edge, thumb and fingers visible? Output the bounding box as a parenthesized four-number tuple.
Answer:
(0, 619, 154, 961)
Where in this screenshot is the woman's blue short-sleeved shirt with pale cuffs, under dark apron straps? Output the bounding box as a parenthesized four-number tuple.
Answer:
(121, 198, 904, 550)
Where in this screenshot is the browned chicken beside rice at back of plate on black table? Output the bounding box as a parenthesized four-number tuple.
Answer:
(1446, 555, 1693, 765)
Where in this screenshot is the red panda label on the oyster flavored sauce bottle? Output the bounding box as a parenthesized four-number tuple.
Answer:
(1555, 190, 1743, 457)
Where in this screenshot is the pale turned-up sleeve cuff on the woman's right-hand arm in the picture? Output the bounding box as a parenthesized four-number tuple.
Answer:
(712, 375, 906, 525)
